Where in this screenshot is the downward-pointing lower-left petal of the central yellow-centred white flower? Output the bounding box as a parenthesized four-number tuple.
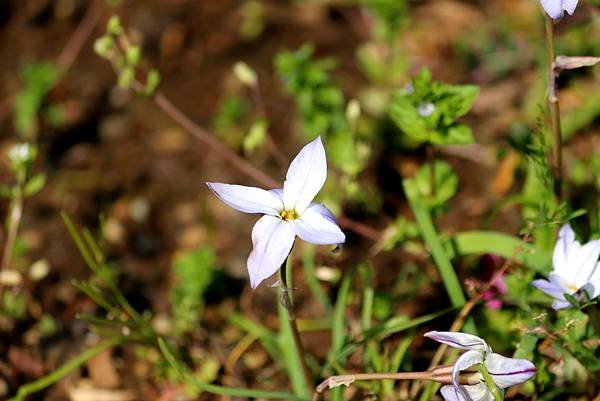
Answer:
(248, 216, 296, 288)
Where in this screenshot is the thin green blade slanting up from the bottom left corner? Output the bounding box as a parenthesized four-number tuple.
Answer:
(8, 338, 122, 401)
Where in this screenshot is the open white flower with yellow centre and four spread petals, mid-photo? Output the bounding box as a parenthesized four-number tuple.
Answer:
(207, 137, 346, 288)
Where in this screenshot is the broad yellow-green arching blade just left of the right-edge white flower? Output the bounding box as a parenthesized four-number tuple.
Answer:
(445, 231, 552, 272)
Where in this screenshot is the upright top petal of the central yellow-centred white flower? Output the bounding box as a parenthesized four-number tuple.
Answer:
(283, 137, 327, 214)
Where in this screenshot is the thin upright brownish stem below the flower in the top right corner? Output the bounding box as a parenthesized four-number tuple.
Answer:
(545, 15, 562, 202)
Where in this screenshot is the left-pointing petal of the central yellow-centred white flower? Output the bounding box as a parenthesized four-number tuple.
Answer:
(206, 182, 283, 216)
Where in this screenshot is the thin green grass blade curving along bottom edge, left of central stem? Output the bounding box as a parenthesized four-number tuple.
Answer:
(158, 338, 308, 401)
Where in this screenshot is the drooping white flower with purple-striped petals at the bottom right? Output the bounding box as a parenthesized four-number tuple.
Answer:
(425, 331, 536, 401)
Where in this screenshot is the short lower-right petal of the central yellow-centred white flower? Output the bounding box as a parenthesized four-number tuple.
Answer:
(290, 204, 346, 245)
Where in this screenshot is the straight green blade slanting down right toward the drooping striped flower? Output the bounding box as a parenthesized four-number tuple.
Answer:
(402, 179, 477, 334)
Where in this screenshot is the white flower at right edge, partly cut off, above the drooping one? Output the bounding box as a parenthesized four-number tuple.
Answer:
(531, 224, 600, 310)
